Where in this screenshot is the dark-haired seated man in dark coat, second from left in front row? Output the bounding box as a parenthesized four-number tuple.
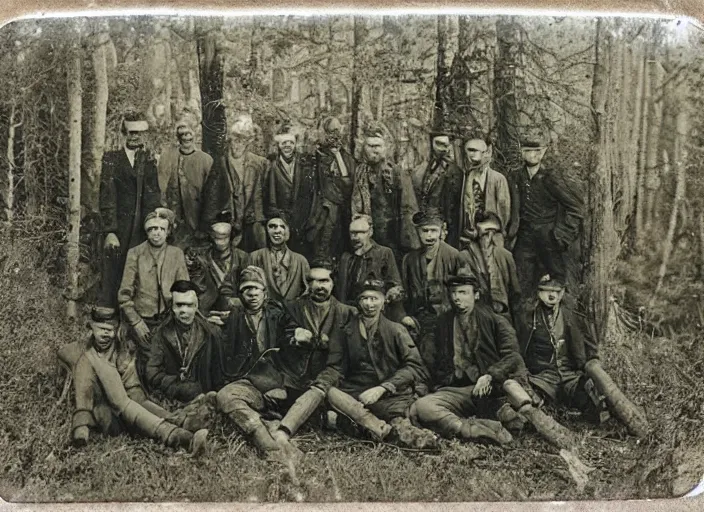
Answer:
(147, 281, 219, 402)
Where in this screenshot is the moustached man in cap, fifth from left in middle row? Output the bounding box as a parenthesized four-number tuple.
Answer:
(401, 208, 466, 372)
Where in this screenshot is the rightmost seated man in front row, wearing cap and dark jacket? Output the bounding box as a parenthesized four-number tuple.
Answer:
(519, 275, 604, 419)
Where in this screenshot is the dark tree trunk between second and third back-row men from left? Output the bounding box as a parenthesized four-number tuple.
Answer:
(196, 18, 227, 157)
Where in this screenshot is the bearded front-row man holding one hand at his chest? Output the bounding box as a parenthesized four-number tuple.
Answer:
(258, 260, 356, 452)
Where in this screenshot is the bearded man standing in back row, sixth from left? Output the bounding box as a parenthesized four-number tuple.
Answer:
(352, 125, 419, 261)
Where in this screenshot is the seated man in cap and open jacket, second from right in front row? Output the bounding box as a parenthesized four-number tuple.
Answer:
(412, 269, 525, 444)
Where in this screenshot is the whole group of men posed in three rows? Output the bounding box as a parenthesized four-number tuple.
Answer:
(64, 108, 616, 459)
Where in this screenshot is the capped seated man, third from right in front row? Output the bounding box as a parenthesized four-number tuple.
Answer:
(328, 281, 428, 433)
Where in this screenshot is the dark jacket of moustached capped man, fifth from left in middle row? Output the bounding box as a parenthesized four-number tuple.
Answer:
(401, 241, 466, 316)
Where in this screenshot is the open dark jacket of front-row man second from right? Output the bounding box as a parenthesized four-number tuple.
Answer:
(430, 304, 525, 388)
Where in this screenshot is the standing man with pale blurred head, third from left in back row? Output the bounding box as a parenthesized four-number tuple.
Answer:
(201, 115, 268, 252)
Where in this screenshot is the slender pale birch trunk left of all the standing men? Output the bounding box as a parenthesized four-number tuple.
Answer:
(66, 43, 83, 319)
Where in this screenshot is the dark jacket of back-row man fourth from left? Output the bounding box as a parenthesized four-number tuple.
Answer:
(264, 154, 316, 252)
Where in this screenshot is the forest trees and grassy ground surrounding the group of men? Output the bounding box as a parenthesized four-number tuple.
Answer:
(0, 15, 704, 500)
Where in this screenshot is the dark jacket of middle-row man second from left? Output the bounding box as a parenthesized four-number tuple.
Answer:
(189, 246, 249, 313)
